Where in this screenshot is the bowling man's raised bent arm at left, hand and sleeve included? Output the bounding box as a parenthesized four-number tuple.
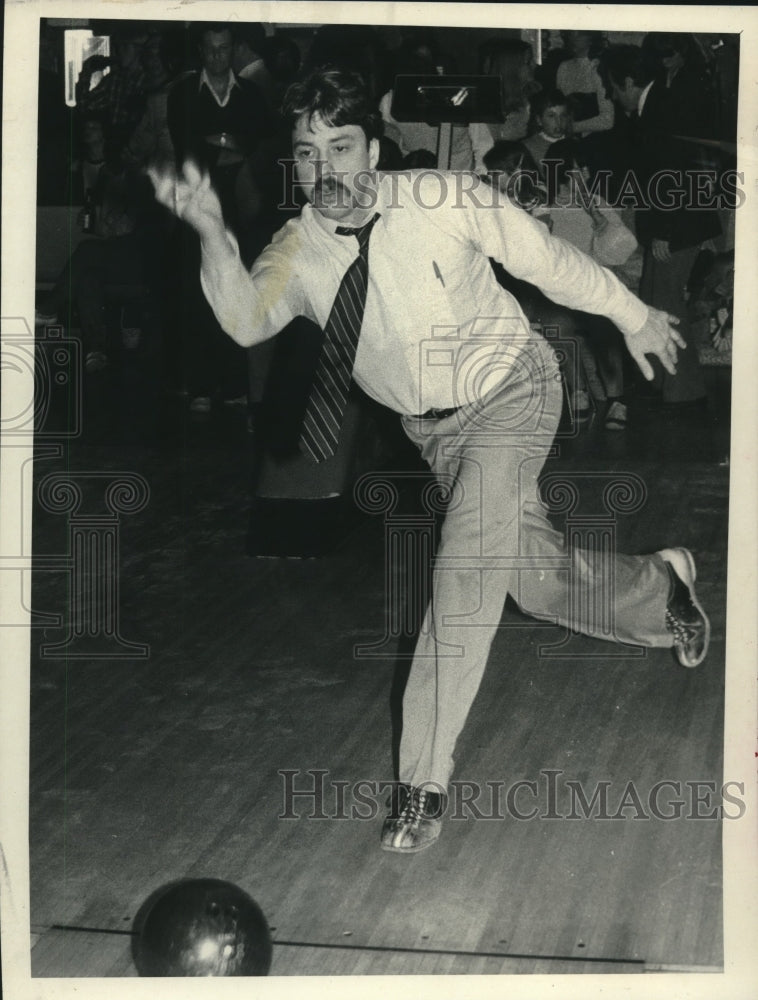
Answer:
(149, 161, 302, 347)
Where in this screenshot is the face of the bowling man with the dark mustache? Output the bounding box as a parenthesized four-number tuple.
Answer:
(292, 113, 379, 222)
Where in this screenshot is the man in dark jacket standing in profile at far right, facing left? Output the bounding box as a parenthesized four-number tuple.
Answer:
(604, 33, 721, 409)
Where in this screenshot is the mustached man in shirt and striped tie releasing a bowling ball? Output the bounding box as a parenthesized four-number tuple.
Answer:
(153, 69, 710, 853)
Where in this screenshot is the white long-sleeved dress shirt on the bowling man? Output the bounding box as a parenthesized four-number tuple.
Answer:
(201, 171, 648, 414)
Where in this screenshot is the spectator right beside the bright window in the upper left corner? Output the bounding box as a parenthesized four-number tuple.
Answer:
(76, 28, 148, 154)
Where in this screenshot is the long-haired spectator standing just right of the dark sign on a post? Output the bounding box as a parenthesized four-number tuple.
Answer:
(469, 38, 540, 173)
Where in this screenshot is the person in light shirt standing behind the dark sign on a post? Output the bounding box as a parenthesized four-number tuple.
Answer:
(379, 32, 474, 170)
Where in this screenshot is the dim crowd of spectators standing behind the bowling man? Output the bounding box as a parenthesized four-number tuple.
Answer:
(37, 21, 739, 430)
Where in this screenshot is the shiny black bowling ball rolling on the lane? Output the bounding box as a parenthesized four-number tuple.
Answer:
(134, 878, 271, 976)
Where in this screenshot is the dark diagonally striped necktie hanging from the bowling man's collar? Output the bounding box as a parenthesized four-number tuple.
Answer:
(300, 213, 379, 462)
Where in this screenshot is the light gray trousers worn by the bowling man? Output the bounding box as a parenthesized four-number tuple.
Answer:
(399, 335, 672, 788)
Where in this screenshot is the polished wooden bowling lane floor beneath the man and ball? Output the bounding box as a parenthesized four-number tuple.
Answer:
(30, 390, 728, 976)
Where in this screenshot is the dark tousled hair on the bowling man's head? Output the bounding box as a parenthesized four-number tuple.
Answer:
(282, 66, 384, 141)
